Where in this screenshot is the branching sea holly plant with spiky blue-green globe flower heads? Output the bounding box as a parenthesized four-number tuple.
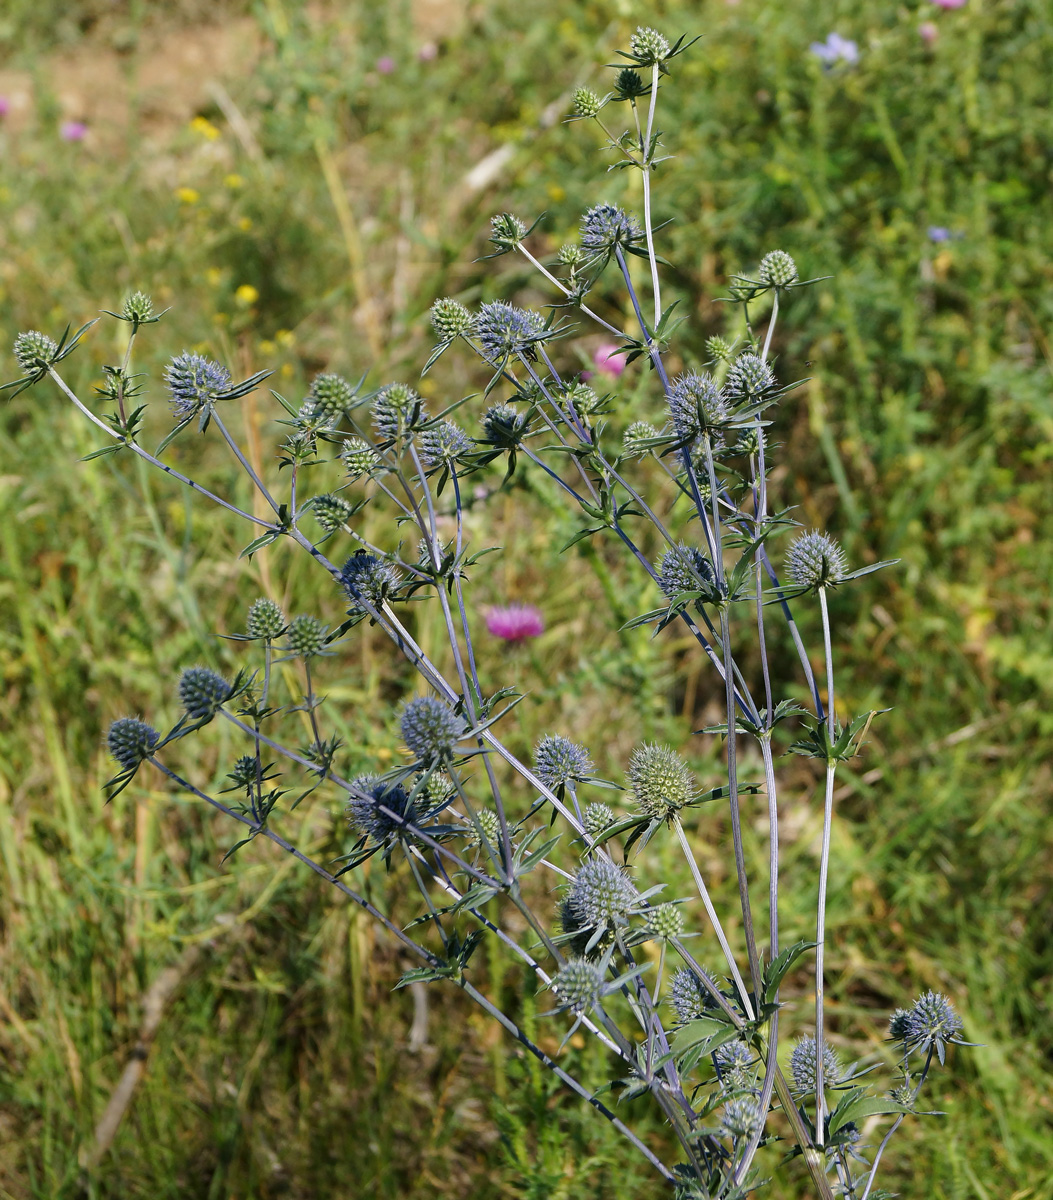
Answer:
(7, 29, 964, 1200)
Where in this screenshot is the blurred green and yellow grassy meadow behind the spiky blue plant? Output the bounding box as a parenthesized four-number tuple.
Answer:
(0, 0, 1053, 1200)
